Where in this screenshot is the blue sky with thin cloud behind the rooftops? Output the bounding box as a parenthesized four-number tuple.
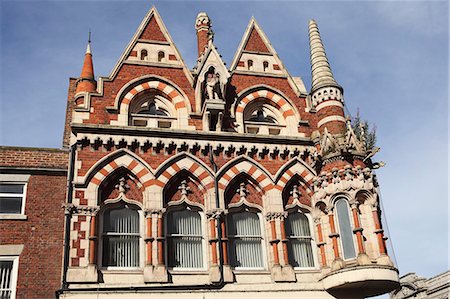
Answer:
(0, 1, 449, 286)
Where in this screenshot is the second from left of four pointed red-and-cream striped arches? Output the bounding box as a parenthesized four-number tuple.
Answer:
(154, 153, 214, 190)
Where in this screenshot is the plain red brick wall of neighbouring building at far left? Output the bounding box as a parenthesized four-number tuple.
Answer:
(0, 175, 66, 299)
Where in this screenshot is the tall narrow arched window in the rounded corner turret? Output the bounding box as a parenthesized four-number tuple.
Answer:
(335, 198, 356, 259)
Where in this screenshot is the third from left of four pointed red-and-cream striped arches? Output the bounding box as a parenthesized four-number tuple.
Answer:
(218, 157, 273, 193)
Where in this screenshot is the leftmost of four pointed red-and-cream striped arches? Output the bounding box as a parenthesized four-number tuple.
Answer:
(88, 151, 153, 190)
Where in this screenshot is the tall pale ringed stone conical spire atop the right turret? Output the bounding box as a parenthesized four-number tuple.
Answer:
(309, 20, 341, 93)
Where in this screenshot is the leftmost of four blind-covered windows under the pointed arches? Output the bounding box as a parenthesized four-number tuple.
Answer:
(102, 205, 140, 268)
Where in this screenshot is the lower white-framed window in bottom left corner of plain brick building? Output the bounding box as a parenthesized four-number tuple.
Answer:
(0, 256, 19, 299)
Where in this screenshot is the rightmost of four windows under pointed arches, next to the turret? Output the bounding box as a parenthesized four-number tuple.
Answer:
(286, 213, 314, 268)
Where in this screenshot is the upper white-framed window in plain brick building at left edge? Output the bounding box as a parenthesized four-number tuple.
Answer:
(0, 182, 27, 215)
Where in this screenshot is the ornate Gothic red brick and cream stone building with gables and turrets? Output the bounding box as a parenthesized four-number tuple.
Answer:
(0, 8, 398, 298)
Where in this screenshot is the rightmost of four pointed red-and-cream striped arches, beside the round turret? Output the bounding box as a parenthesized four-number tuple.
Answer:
(274, 158, 316, 195)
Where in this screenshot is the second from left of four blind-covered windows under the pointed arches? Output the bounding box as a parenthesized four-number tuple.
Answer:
(167, 210, 203, 269)
